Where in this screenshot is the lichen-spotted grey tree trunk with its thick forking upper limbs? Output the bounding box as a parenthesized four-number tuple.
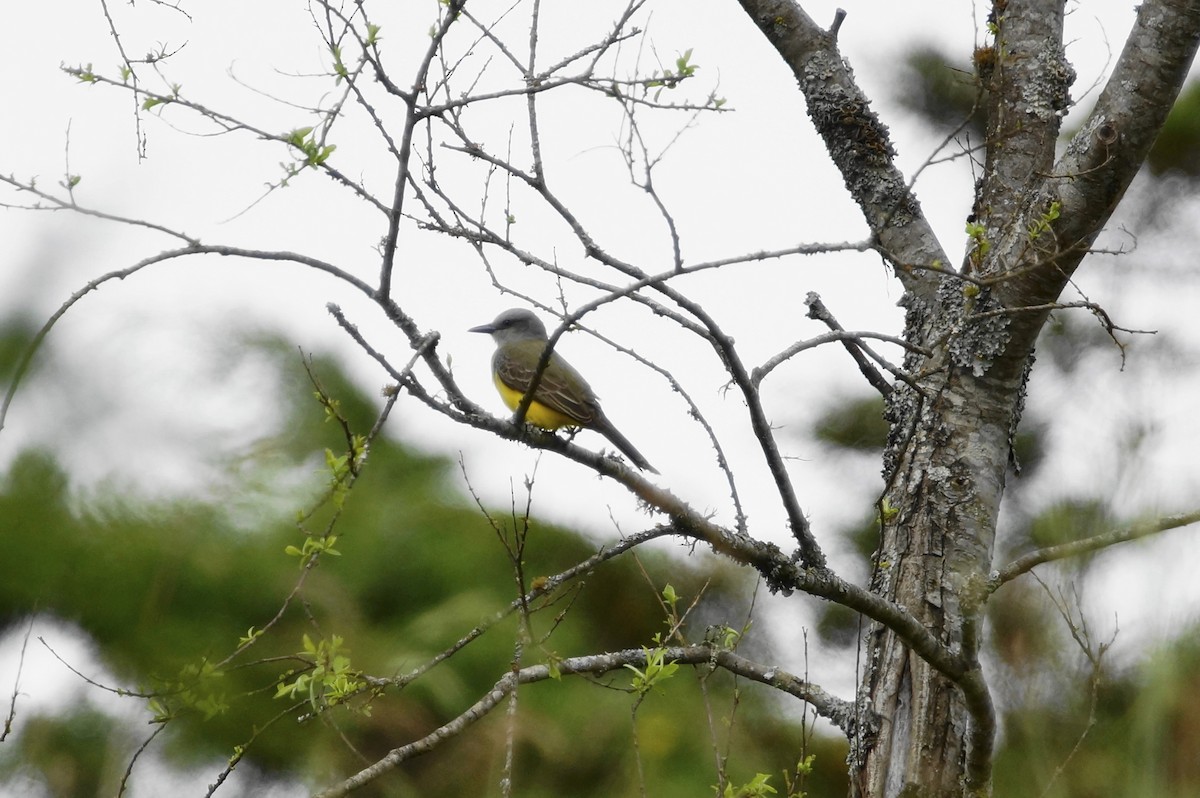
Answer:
(739, 0, 1200, 798)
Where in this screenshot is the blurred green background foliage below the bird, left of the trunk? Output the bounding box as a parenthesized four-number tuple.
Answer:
(0, 331, 845, 798)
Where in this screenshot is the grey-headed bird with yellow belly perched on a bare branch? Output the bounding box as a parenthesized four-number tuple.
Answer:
(469, 307, 659, 474)
